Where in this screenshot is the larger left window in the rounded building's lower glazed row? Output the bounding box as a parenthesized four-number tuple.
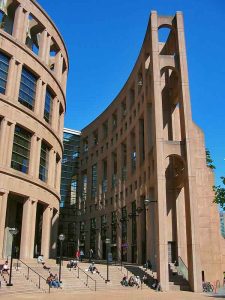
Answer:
(11, 126, 31, 173)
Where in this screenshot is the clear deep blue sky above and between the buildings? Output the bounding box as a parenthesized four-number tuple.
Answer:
(38, 0, 225, 183)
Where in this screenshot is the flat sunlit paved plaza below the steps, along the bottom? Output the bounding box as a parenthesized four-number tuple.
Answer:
(1, 288, 222, 300)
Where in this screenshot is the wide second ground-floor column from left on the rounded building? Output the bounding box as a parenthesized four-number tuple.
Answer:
(20, 198, 37, 259)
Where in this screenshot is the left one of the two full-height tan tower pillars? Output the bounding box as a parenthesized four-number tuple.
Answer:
(150, 11, 169, 291)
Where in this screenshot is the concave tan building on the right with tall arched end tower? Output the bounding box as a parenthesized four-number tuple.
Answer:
(77, 12, 222, 292)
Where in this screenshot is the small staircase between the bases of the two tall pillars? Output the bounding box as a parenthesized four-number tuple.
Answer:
(169, 263, 191, 291)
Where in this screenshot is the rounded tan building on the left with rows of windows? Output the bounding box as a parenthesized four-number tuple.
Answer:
(0, 0, 68, 258)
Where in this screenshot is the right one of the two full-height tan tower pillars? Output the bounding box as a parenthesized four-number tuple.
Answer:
(176, 12, 202, 292)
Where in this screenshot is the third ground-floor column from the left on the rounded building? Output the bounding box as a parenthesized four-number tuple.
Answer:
(41, 206, 53, 259)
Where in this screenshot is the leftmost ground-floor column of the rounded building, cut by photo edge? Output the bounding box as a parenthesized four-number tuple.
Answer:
(0, 192, 9, 258)
